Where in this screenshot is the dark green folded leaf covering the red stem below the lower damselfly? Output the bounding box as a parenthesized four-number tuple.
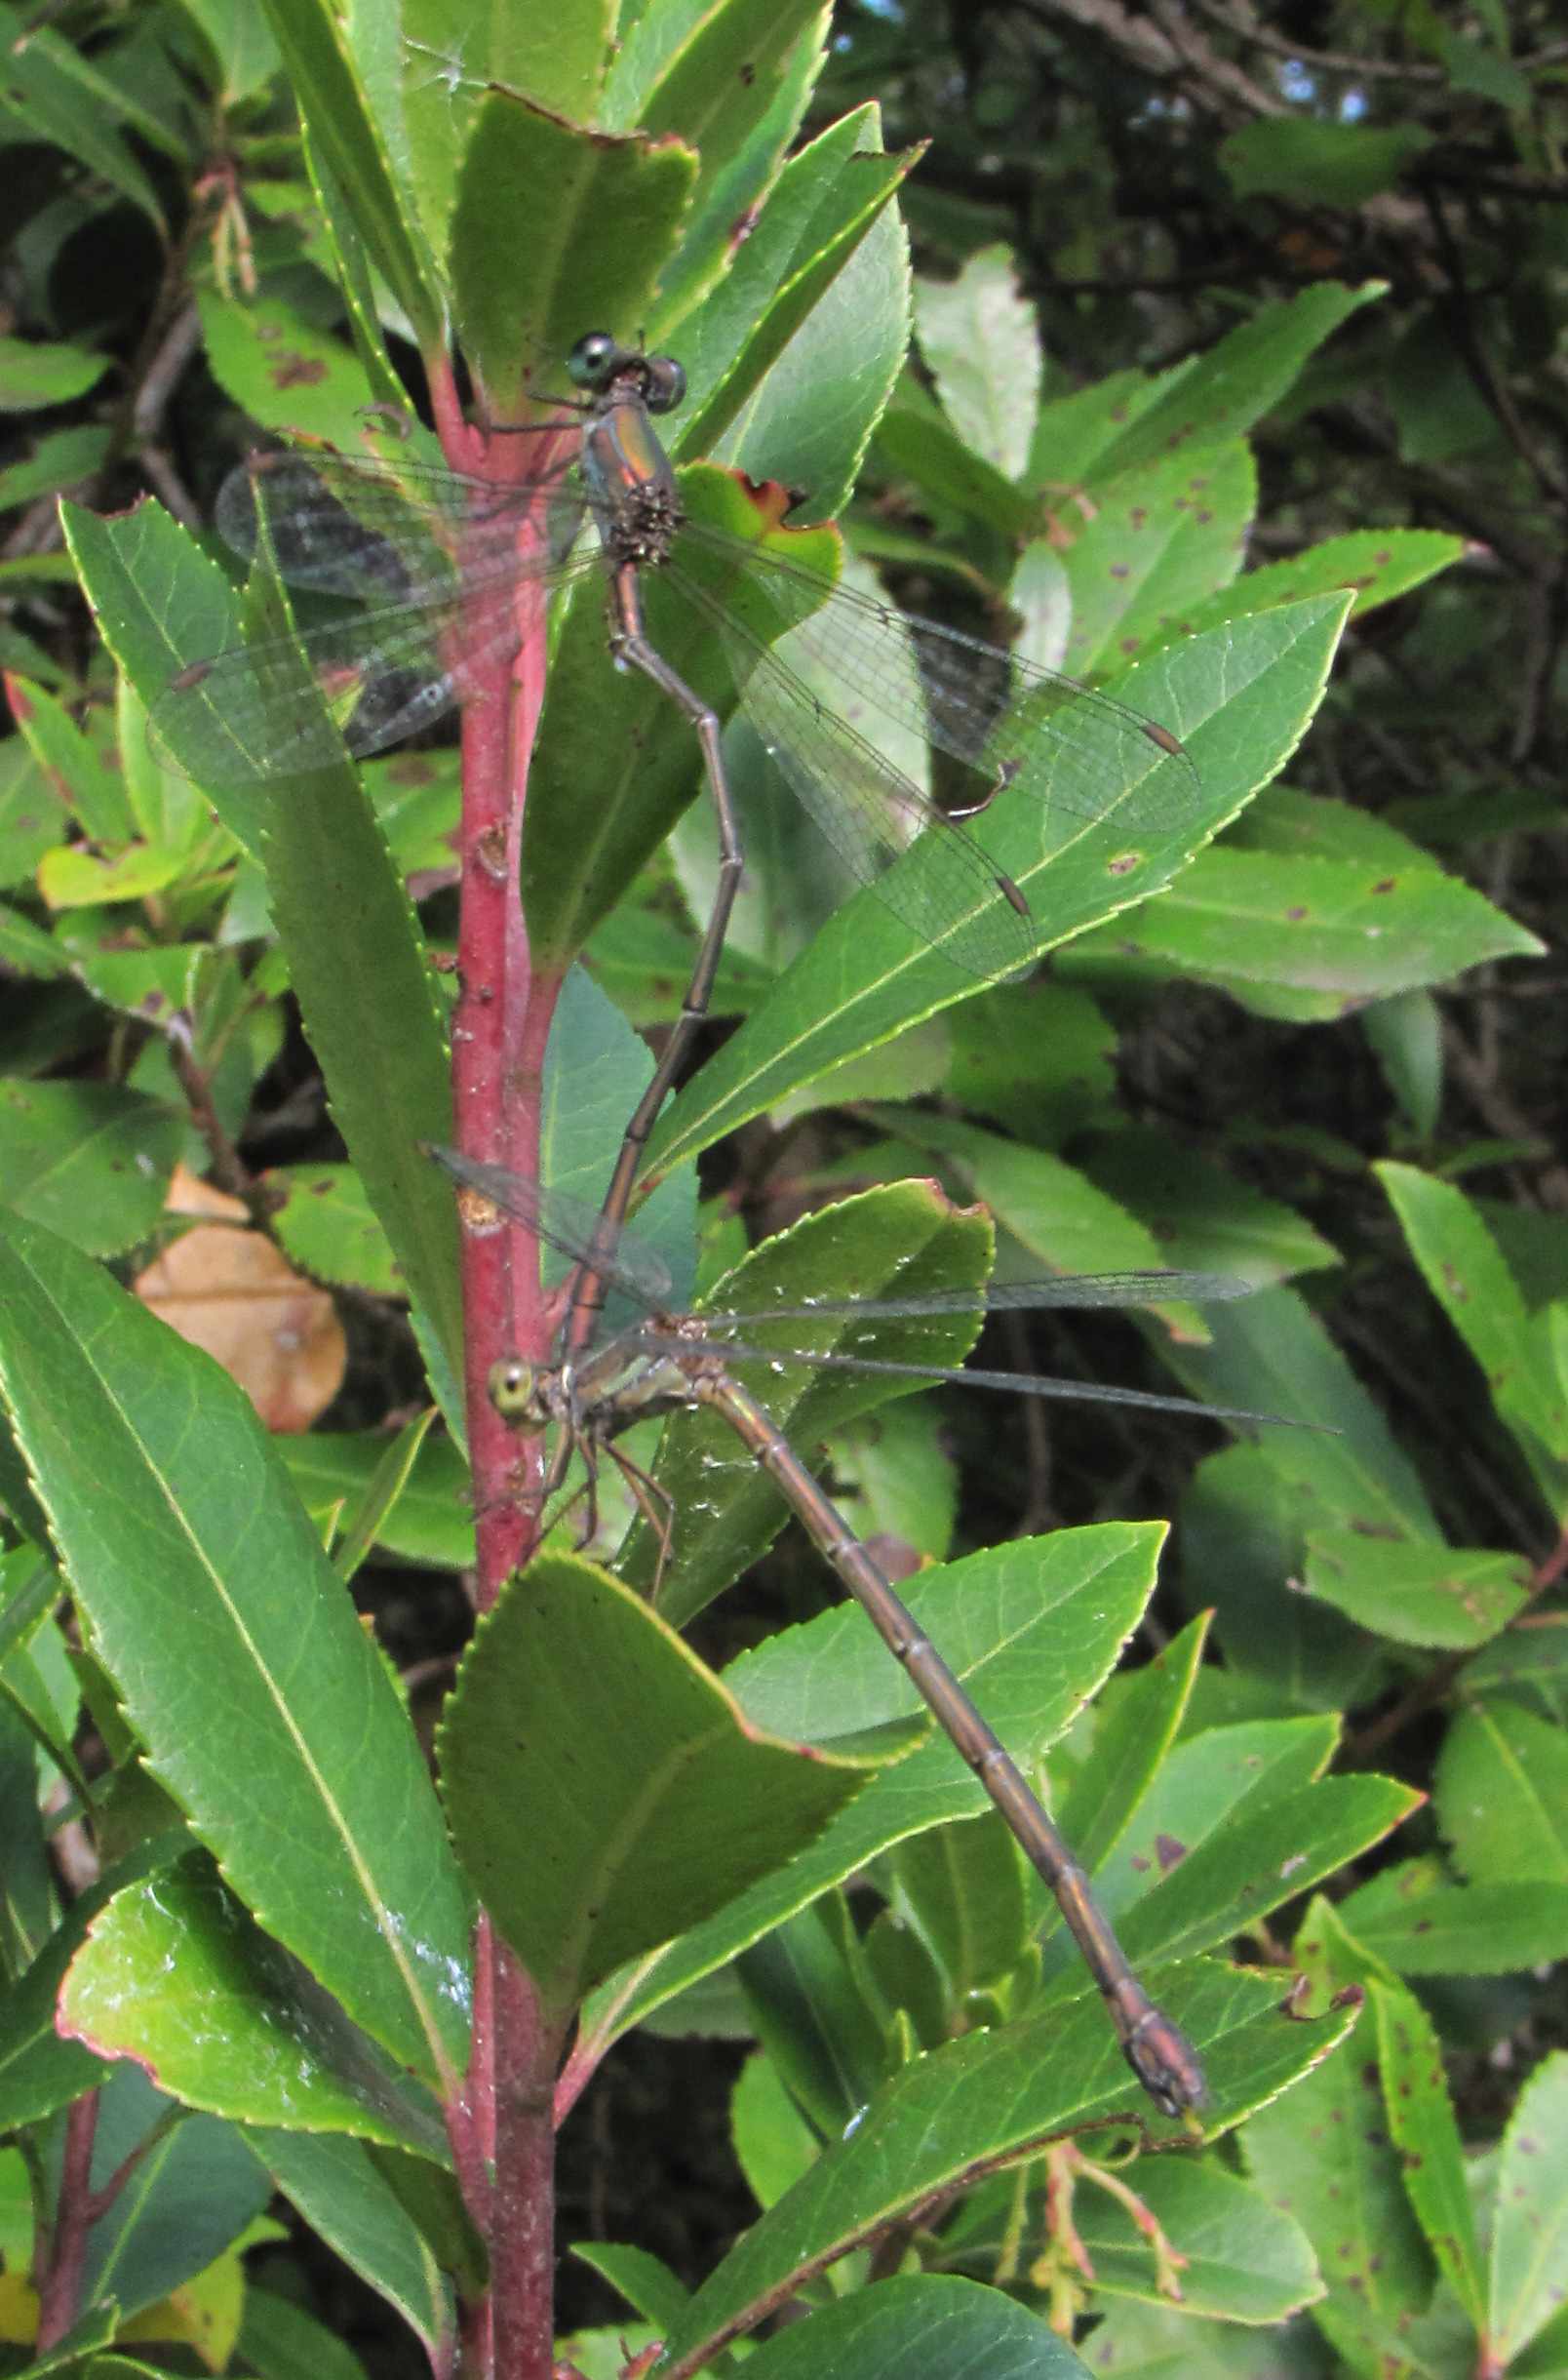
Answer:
(440, 1554, 866, 2023)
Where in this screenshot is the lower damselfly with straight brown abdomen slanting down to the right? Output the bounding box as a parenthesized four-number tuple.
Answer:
(428, 1150, 1304, 2116)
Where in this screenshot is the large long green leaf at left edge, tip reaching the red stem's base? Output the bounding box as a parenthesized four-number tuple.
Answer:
(0, 1218, 469, 2076)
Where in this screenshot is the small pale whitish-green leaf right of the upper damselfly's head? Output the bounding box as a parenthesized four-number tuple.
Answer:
(914, 245, 1039, 478)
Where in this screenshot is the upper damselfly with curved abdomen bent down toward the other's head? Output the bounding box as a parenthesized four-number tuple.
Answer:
(152, 331, 1196, 1345)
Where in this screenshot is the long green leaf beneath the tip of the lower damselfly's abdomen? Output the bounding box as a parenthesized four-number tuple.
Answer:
(661, 1970, 1350, 2380)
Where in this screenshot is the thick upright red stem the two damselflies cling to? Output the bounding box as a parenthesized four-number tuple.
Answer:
(431, 344, 562, 2380)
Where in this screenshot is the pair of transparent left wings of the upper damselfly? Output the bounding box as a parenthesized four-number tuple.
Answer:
(150, 455, 595, 785)
